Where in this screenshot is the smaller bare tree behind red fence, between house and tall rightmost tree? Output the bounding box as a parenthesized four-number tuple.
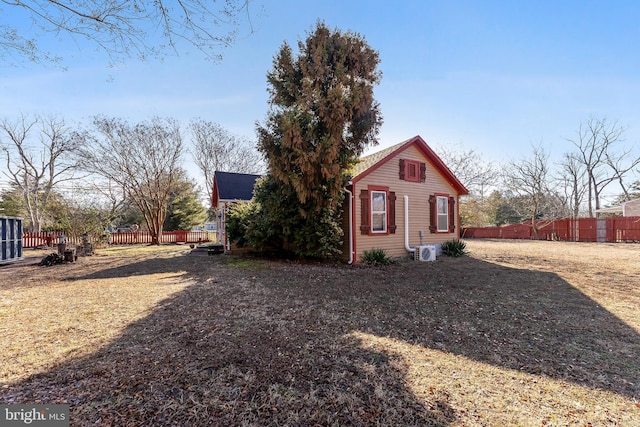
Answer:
(504, 146, 552, 239)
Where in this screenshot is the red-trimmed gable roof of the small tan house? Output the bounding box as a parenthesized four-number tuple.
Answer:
(352, 135, 469, 195)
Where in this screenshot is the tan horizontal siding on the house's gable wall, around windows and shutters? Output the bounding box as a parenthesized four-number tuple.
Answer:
(345, 146, 460, 259)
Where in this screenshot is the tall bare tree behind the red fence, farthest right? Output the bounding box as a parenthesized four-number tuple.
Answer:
(569, 117, 640, 217)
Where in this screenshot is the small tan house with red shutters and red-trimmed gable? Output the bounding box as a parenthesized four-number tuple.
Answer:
(342, 136, 469, 263)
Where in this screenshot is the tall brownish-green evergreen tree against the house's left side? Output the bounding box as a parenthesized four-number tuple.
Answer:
(248, 22, 382, 256)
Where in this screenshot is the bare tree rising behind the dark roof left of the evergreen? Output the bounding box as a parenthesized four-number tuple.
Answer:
(189, 119, 264, 200)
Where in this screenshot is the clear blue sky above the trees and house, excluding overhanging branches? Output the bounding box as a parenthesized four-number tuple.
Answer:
(0, 0, 640, 199)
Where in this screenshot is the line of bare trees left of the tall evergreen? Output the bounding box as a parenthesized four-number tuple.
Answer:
(0, 115, 263, 243)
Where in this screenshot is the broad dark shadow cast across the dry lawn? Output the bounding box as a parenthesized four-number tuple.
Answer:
(0, 252, 640, 426)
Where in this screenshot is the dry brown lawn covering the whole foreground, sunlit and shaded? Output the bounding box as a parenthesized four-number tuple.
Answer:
(0, 240, 640, 427)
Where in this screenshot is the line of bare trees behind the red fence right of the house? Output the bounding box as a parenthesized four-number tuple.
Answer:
(437, 117, 640, 233)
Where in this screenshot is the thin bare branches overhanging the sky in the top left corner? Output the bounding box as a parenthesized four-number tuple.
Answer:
(0, 0, 253, 66)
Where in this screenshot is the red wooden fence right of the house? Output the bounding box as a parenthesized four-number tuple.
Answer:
(462, 216, 640, 243)
